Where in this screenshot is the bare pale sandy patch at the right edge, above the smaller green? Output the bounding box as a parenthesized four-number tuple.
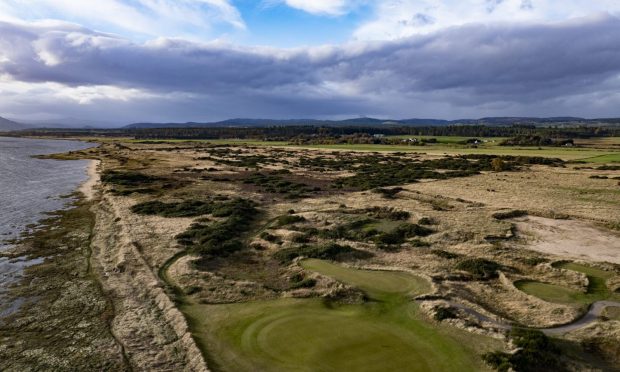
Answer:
(516, 216, 620, 264)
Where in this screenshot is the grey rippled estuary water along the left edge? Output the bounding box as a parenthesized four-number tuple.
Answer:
(0, 137, 93, 317)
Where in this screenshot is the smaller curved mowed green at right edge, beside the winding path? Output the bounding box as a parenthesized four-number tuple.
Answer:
(515, 262, 620, 306)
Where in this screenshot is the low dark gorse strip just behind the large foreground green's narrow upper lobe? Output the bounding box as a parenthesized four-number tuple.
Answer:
(273, 243, 372, 262)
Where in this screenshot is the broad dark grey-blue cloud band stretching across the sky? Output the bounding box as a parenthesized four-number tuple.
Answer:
(0, 15, 620, 116)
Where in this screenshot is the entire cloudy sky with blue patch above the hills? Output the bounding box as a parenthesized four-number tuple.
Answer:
(0, 0, 620, 124)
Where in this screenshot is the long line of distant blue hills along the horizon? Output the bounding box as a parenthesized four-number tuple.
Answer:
(123, 117, 620, 129)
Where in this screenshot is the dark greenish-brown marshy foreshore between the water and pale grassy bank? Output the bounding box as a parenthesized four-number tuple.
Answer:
(0, 201, 129, 371)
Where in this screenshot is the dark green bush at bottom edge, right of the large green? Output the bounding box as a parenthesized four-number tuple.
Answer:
(483, 328, 567, 372)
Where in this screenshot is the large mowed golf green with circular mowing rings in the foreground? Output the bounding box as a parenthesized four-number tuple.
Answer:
(182, 260, 489, 371)
